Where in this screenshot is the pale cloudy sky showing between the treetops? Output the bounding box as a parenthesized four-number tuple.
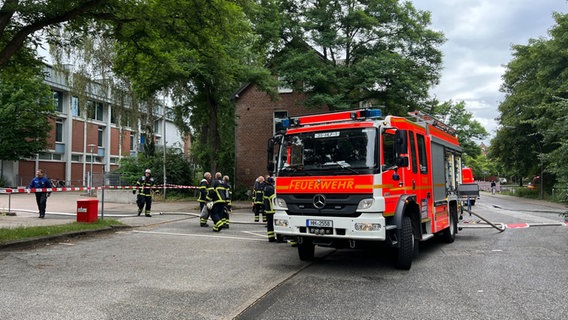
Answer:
(409, 0, 568, 145)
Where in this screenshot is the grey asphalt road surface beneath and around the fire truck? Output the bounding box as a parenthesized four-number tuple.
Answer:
(0, 194, 568, 320)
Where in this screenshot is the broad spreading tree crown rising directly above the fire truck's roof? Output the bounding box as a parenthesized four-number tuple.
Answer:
(274, 0, 444, 115)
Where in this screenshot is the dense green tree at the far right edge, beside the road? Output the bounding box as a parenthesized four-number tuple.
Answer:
(489, 13, 568, 195)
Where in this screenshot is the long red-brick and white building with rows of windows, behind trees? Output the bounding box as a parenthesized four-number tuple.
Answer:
(0, 66, 186, 187)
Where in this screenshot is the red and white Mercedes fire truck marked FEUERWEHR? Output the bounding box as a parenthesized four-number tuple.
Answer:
(268, 109, 462, 269)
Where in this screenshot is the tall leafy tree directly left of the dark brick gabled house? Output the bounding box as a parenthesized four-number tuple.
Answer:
(114, 0, 276, 172)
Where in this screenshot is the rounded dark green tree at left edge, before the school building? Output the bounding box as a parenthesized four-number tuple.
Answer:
(0, 64, 55, 160)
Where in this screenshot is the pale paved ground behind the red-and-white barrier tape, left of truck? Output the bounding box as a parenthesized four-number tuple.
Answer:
(0, 192, 254, 229)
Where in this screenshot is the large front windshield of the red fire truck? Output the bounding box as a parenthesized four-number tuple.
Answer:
(278, 128, 378, 175)
